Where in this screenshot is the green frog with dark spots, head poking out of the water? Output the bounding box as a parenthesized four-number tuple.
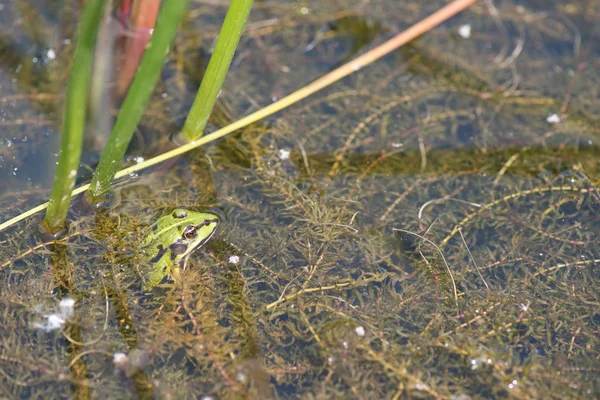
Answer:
(142, 208, 221, 290)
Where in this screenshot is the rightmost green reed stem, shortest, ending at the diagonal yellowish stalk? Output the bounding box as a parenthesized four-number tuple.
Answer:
(181, 0, 253, 142)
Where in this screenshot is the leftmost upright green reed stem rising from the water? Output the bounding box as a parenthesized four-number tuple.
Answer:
(42, 0, 104, 234)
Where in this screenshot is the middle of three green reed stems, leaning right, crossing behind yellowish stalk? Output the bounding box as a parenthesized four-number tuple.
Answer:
(87, 0, 188, 203)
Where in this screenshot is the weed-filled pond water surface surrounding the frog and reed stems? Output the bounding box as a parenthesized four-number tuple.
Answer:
(0, 0, 600, 399)
